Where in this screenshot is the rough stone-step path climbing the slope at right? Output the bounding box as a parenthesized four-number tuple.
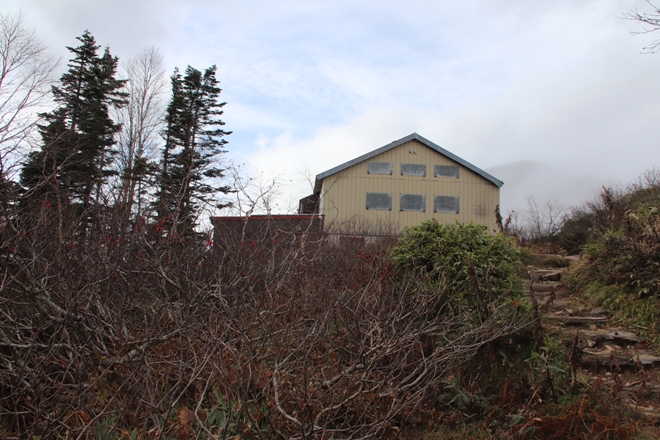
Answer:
(527, 257, 660, 424)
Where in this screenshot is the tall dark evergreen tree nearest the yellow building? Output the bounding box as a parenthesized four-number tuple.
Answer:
(157, 66, 231, 233)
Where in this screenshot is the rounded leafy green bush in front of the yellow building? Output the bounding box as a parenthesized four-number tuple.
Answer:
(390, 219, 530, 337)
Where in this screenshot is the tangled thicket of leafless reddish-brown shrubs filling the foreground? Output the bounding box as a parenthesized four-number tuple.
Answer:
(0, 199, 529, 438)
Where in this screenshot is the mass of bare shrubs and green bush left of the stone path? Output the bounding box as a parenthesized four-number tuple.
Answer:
(6, 202, 656, 439)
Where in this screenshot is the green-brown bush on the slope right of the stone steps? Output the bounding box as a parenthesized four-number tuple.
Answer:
(566, 180, 660, 347)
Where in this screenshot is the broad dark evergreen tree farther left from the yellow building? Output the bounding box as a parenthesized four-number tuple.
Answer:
(21, 31, 126, 208)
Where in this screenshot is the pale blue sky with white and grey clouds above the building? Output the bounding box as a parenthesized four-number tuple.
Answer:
(5, 0, 660, 212)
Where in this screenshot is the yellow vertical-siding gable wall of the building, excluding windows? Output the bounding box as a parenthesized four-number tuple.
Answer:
(321, 140, 500, 232)
